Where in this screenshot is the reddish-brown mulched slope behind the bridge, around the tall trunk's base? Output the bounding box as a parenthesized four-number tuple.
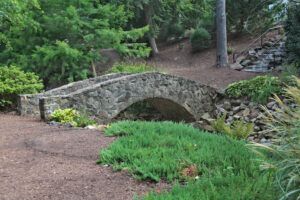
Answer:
(148, 37, 259, 89)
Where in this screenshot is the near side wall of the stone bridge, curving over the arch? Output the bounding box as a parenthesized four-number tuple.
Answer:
(40, 73, 217, 123)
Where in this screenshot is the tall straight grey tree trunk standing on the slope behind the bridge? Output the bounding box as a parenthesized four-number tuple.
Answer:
(216, 0, 228, 67)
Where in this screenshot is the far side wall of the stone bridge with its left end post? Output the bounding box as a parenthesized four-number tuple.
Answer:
(18, 73, 127, 117)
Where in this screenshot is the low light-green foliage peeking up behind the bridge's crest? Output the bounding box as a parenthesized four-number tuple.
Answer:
(107, 63, 157, 74)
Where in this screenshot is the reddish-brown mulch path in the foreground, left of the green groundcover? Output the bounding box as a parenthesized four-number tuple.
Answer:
(0, 113, 163, 200)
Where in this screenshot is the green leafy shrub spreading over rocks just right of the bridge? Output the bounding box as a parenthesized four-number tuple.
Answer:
(225, 76, 282, 103)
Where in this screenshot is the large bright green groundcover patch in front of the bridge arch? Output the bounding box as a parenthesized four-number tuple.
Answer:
(98, 121, 276, 199)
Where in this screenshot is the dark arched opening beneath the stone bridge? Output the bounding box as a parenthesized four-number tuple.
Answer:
(112, 98, 196, 123)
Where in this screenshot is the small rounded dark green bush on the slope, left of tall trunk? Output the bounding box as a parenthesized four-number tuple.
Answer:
(190, 28, 211, 52)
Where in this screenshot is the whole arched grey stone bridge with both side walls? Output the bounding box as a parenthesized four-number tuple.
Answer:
(19, 72, 218, 123)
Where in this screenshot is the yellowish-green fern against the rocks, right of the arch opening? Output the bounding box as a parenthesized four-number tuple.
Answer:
(212, 115, 254, 139)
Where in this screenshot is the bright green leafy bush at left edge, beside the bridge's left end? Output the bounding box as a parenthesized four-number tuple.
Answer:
(0, 66, 43, 108)
